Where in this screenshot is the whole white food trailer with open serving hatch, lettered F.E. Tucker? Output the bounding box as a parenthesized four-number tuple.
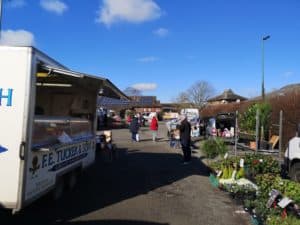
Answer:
(0, 46, 121, 212)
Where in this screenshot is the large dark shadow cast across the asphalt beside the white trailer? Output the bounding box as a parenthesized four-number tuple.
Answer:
(0, 145, 209, 225)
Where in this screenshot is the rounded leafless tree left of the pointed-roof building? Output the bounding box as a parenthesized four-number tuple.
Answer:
(186, 81, 215, 109)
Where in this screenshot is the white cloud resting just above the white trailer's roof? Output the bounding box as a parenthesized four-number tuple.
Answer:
(0, 30, 34, 46)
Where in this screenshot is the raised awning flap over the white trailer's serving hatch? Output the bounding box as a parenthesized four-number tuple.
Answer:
(37, 64, 128, 99)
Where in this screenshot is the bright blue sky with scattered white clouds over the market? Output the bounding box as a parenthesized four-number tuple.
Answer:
(0, 0, 300, 102)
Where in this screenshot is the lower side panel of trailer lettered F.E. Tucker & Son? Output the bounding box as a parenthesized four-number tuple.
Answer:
(25, 138, 95, 200)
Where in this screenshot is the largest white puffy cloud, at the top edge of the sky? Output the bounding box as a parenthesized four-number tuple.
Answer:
(96, 0, 162, 26)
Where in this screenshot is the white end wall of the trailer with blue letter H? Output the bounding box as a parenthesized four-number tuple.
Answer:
(0, 46, 31, 209)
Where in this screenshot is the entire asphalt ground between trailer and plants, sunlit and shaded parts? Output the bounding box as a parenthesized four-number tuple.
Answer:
(0, 123, 250, 225)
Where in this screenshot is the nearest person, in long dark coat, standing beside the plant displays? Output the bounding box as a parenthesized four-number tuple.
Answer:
(179, 115, 192, 164)
